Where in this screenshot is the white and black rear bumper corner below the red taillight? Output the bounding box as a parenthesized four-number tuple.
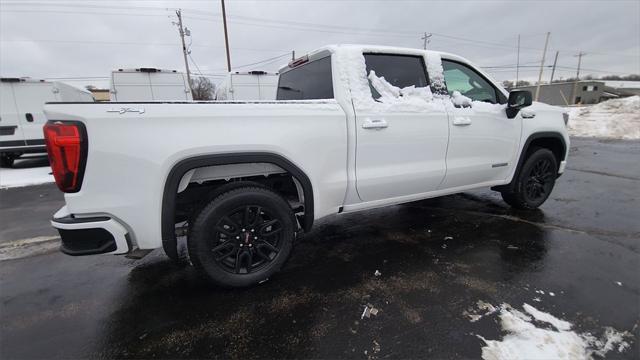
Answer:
(51, 206, 131, 256)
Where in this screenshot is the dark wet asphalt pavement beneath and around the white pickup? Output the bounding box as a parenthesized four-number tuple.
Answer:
(0, 139, 640, 359)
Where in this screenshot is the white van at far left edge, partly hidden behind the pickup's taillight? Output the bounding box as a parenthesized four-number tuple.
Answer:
(0, 78, 94, 167)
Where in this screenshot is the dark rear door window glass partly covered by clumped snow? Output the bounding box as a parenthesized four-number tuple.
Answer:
(364, 54, 429, 99)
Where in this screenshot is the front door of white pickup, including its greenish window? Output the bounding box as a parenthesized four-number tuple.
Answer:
(440, 59, 522, 189)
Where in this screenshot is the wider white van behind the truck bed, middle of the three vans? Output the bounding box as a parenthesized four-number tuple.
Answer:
(110, 68, 193, 101)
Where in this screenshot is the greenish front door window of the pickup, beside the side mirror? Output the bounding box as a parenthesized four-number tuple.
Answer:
(442, 59, 504, 104)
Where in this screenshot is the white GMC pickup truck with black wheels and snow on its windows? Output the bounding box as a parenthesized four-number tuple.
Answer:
(44, 45, 569, 286)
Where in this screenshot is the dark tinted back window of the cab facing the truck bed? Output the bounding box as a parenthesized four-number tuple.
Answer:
(276, 56, 333, 100)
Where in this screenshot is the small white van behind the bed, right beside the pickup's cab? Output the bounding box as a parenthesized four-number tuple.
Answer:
(215, 71, 278, 100)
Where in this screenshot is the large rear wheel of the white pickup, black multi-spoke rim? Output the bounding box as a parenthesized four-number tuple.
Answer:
(188, 187, 296, 287)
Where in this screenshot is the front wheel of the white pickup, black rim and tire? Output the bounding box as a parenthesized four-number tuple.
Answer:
(501, 148, 558, 210)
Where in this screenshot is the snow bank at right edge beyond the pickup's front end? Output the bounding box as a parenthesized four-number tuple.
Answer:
(569, 95, 640, 139)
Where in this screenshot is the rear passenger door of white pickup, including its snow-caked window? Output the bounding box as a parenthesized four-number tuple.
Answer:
(352, 54, 448, 201)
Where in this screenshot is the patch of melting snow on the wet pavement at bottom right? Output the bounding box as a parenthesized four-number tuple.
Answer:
(472, 304, 631, 360)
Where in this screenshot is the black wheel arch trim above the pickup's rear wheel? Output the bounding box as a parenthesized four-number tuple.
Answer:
(160, 152, 314, 260)
